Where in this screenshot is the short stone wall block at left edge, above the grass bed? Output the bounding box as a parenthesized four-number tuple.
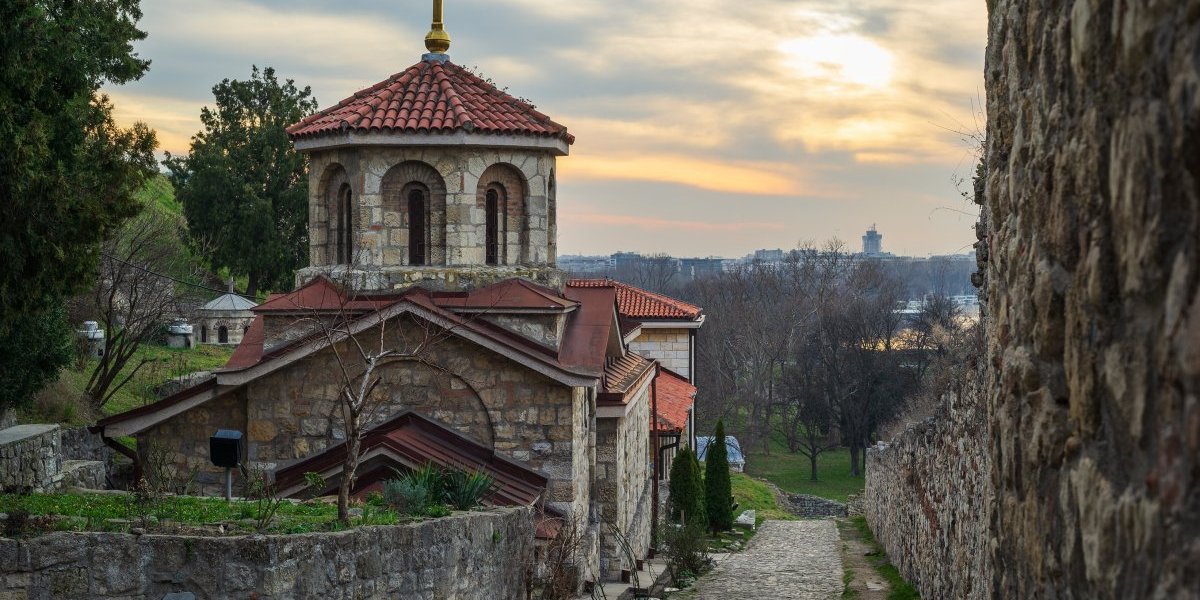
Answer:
(0, 425, 62, 492)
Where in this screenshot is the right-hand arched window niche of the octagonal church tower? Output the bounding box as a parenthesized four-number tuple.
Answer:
(475, 162, 529, 264)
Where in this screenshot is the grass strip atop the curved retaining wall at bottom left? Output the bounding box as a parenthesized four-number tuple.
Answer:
(0, 493, 413, 535)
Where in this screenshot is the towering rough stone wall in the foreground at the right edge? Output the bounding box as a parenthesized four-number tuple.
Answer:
(984, 0, 1200, 599)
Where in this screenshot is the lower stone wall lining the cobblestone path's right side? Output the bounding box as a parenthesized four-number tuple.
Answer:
(864, 374, 994, 599)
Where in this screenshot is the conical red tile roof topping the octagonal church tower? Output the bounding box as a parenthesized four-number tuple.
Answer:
(288, 60, 575, 144)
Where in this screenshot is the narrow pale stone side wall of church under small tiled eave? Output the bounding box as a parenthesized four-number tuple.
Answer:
(596, 388, 654, 578)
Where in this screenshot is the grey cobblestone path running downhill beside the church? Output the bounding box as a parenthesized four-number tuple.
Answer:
(684, 520, 842, 600)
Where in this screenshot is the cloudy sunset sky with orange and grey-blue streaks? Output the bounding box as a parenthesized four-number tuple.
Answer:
(107, 0, 986, 256)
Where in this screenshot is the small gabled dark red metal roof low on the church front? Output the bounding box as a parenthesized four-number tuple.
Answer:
(275, 412, 547, 506)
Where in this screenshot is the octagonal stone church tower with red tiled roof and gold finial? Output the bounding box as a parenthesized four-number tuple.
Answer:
(288, 0, 575, 290)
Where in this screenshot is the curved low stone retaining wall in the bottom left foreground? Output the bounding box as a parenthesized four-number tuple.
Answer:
(0, 508, 534, 600)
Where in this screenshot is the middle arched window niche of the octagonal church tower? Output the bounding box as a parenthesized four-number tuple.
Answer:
(379, 161, 446, 265)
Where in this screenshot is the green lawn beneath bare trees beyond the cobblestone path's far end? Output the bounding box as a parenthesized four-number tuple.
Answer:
(746, 440, 864, 502)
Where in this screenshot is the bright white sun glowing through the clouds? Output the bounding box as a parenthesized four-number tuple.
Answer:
(779, 34, 895, 89)
